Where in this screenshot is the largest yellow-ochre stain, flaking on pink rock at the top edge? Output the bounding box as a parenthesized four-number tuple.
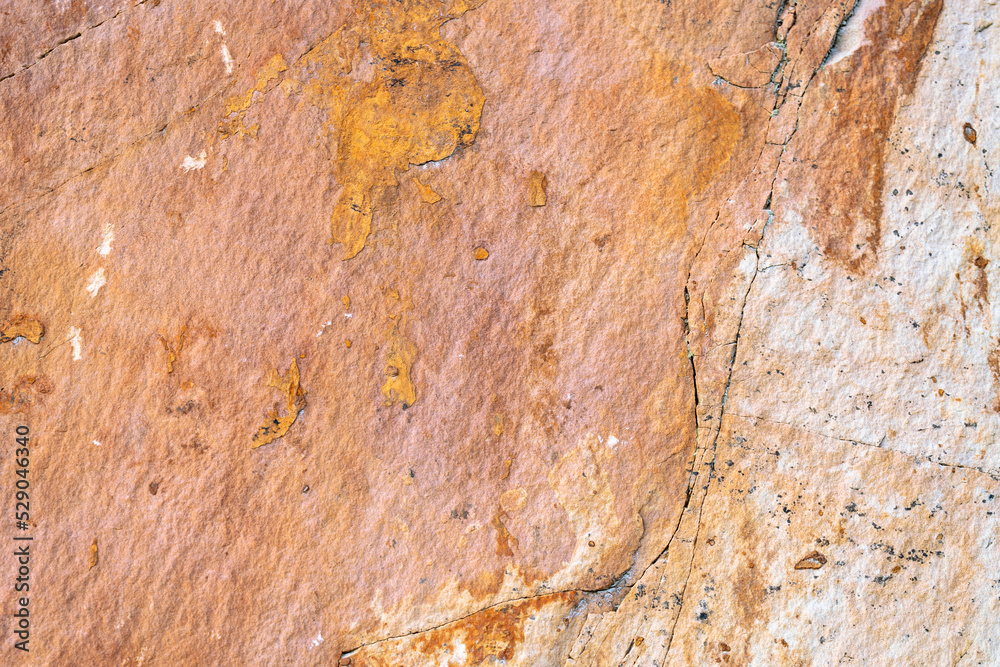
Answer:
(296, 0, 485, 260)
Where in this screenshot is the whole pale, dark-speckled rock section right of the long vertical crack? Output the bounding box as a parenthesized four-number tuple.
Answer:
(656, 1, 1000, 666)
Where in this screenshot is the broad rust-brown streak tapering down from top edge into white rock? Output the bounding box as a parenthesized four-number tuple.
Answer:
(789, 0, 942, 273)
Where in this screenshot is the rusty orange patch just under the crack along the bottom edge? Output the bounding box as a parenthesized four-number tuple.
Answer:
(414, 591, 581, 665)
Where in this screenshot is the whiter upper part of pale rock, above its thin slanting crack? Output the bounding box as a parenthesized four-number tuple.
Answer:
(727, 4, 1000, 474)
